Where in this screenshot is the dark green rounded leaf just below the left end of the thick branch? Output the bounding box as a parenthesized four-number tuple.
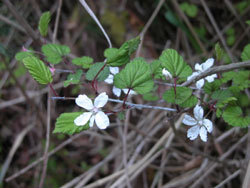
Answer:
(162, 87, 192, 104)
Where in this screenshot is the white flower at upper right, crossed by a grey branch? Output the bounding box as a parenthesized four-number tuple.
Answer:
(187, 58, 217, 89)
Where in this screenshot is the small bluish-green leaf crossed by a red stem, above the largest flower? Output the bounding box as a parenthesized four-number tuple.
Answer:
(86, 62, 109, 81)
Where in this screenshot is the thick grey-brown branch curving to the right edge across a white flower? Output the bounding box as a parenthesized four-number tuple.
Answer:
(182, 61, 250, 86)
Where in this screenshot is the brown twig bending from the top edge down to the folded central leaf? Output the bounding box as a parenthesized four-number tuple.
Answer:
(136, 0, 165, 57)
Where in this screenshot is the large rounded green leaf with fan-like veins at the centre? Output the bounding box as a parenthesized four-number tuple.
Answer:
(114, 58, 154, 94)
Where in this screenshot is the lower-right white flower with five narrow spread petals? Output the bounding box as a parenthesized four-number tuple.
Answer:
(182, 105, 213, 142)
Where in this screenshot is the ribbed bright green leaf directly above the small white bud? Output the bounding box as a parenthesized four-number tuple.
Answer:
(160, 49, 192, 79)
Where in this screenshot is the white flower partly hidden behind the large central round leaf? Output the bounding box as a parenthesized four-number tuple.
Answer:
(104, 67, 136, 97)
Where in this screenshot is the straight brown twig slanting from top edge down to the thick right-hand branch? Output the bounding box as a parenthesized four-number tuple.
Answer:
(201, 0, 235, 62)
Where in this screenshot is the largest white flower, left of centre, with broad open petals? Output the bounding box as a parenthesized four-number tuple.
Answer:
(74, 92, 109, 129)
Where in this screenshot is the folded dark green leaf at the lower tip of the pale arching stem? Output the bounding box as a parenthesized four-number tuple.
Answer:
(104, 37, 140, 67)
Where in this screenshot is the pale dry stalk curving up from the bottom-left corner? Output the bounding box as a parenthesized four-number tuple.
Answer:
(0, 124, 35, 184)
